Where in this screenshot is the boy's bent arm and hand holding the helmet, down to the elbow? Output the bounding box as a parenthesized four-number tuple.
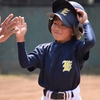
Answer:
(76, 9, 96, 53)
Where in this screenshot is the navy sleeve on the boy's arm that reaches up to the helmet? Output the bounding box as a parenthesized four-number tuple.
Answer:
(77, 22, 96, 60)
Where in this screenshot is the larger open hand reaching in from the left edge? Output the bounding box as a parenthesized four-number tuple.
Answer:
(0, 14, 17, 42)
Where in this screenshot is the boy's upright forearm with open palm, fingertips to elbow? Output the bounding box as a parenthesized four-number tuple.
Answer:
(15, 16, 31, 68)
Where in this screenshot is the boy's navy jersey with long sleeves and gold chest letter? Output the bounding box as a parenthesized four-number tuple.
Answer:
(18, 23, 95, 91)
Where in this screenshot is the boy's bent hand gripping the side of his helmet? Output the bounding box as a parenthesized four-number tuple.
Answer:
(76, 8, 88, 24)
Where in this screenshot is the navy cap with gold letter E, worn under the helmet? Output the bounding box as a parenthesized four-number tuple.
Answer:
(47, 8, 78, 28)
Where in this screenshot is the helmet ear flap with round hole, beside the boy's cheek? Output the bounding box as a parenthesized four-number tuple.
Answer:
(73, 23, 84, 40)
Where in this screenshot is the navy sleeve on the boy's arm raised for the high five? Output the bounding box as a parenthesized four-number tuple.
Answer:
(17, 42, 43, 71)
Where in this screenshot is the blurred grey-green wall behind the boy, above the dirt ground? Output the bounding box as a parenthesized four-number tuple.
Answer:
(0, 0, 100, 74)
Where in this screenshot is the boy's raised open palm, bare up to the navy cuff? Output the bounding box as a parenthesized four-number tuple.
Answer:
(15, 16, 27, 42)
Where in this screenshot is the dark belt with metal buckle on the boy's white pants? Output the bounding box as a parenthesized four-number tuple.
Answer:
(43, 89, 74, 100)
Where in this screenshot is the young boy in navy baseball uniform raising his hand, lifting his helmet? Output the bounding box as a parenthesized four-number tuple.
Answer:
(16, 0, 96, 100)
